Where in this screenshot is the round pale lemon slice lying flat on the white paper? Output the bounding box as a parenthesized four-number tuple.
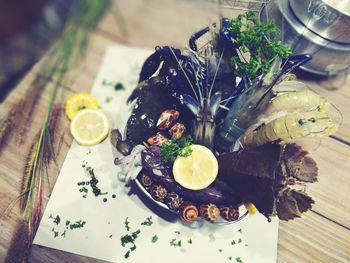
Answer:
(70, 110, 109, 146)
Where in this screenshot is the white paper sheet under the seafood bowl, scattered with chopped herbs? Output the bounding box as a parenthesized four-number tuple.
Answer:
(34, 45, 278, 263)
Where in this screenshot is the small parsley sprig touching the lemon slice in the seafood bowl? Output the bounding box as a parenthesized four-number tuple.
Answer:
(160, 136, 192, 162)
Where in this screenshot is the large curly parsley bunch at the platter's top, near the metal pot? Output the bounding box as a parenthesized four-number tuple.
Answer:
(229, 11, 291, 79)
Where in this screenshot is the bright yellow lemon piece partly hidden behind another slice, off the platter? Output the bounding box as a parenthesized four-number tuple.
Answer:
(66, 92, 99, 120)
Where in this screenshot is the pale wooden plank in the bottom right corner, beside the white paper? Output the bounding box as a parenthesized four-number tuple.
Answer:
(278, 213, 350, 263)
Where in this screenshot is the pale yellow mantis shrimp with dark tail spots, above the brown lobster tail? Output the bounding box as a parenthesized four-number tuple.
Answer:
(240, 111, 337, 147)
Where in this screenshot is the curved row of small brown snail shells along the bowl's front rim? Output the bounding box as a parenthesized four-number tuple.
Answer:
(138, 171, 239, 223)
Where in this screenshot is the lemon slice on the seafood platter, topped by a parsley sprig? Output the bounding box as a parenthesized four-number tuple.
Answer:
(173, 144, 218, 190)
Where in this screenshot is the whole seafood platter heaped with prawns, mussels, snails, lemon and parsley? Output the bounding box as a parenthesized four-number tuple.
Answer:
(110, 12, 338, 224)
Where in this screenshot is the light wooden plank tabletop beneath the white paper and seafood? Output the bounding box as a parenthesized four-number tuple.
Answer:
(0, 0, 350, 263)
